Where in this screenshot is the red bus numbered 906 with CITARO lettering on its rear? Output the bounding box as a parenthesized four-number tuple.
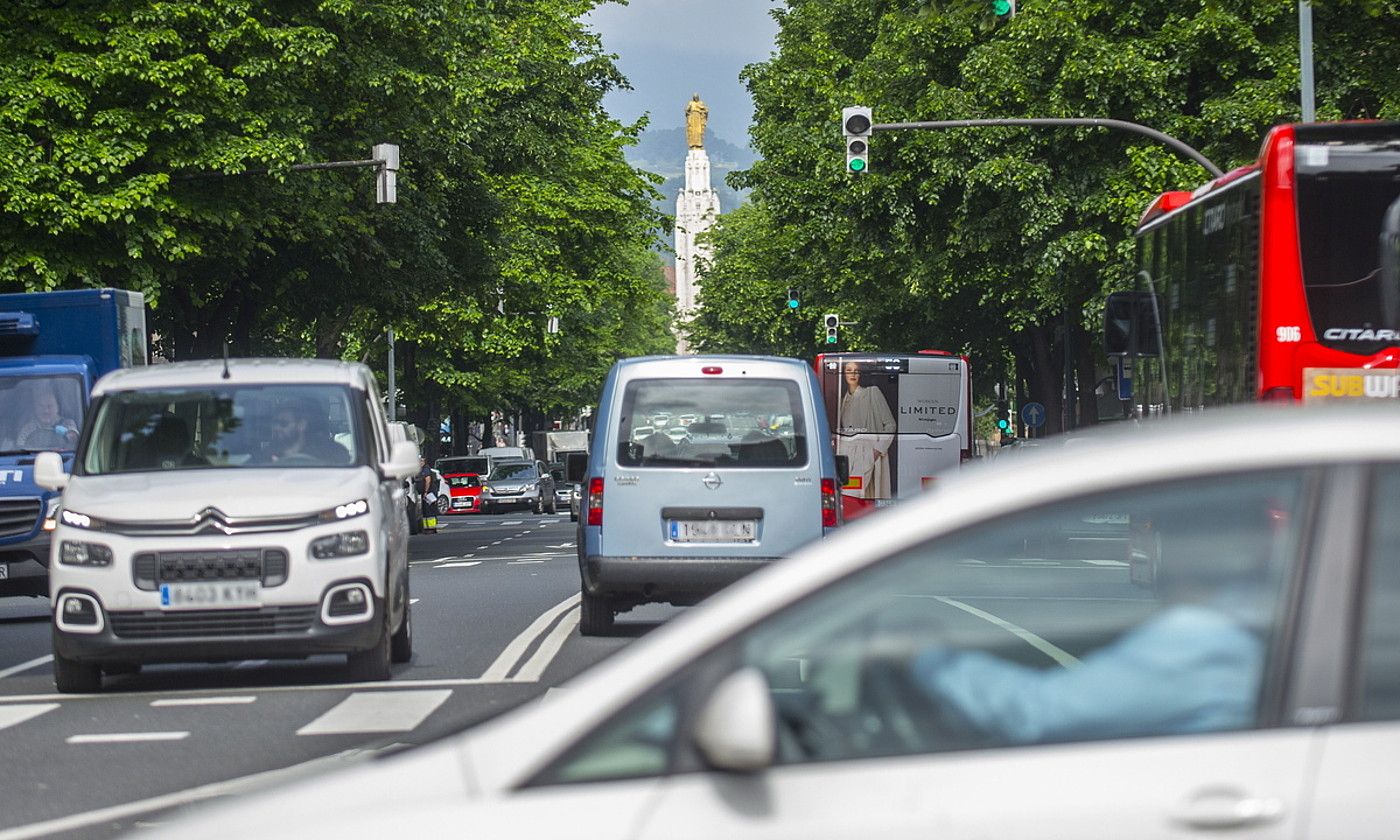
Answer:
(1105, 122, 1400, 414)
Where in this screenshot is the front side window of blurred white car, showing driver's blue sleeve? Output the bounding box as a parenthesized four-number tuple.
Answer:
(741, 472, 1303, 763)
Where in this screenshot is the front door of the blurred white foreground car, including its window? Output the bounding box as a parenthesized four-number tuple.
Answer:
(624, 470, 1321, 840)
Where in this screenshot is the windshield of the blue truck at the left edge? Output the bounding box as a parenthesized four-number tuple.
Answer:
(0, 375, 84, 454)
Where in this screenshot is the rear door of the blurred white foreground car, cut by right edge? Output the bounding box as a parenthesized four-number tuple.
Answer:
(1306, 463, 1400, 840)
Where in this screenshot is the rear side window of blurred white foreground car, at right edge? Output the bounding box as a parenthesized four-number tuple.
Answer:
(1359, 465, 1400, 721)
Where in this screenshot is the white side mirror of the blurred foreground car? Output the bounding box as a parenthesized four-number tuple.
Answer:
(693, 668, 777, 773)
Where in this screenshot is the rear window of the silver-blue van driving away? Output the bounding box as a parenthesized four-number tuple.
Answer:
(617, 379, 806, 468)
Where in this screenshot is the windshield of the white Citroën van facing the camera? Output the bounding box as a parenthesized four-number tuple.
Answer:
(80, 385, 364, 476)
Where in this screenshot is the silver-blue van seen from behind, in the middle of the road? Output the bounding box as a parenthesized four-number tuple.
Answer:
(578, 356, 840, 636)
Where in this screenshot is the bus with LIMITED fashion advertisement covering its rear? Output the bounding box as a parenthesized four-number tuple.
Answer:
(816, 350, 972, 519)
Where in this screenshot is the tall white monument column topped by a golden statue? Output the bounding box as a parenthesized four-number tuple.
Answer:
(676, 94, 720, 353)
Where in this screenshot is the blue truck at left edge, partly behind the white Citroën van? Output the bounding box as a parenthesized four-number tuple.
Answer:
(0, 288, 146, 598)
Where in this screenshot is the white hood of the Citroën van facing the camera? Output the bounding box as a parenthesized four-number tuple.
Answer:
(63, 468, 374, 521)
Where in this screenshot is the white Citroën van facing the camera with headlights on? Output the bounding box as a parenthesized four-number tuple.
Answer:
(35, 360, 419, 692)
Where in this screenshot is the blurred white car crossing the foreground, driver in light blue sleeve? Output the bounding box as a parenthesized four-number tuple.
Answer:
(155, 406, 1400, 840)
